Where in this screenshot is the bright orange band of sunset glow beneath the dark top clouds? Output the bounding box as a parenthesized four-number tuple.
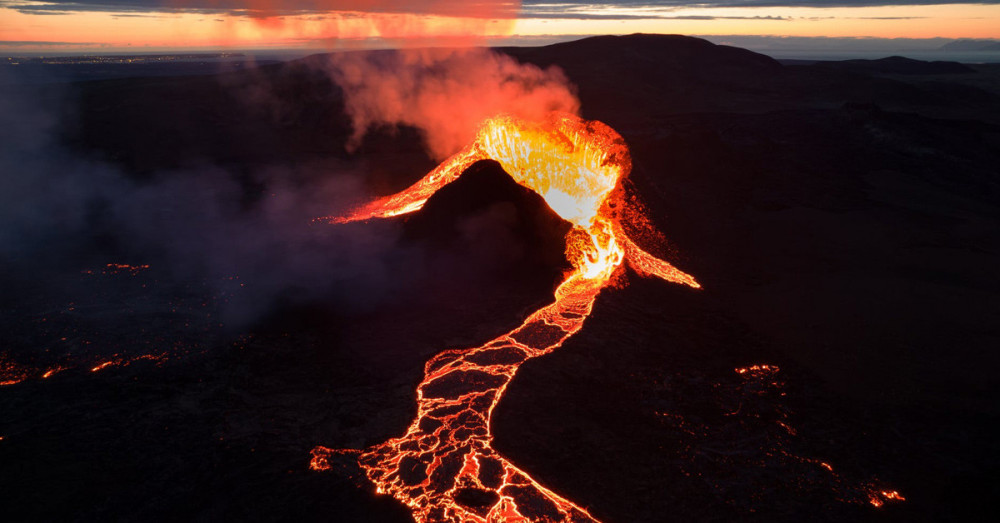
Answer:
(0, 0, 1000, 50)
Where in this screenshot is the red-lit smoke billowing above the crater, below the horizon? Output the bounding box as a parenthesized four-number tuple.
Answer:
(330, 48, 580, 160)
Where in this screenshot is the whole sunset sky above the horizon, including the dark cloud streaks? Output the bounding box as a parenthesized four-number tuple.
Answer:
(0, 0, 1000, 52)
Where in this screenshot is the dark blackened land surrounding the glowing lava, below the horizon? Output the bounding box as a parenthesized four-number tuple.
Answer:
(0, 36, 1000, 522)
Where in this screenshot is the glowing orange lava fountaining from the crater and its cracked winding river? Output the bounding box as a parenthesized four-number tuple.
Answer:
(311, 114, 700, 522)
